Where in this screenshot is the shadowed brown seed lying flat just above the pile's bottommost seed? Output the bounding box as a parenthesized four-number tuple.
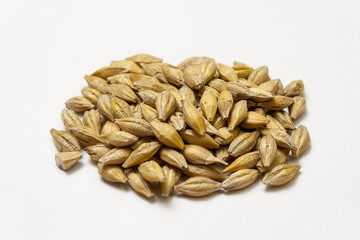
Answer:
(183, 164, 226, 181)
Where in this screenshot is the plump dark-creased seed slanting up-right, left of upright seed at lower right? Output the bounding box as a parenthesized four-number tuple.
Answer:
(229, 131, 260, 157)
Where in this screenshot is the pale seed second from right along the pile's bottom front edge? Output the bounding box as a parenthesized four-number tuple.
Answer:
(222, 169, 260, 191)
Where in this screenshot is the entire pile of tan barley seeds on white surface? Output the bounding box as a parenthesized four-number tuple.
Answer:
(50, 54, 310, 197)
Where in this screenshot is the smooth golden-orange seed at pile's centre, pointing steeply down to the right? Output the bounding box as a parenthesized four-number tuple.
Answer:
(183, 99, 205, 135)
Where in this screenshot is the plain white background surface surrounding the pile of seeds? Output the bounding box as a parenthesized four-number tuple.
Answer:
(0, 0, 360, 240)
